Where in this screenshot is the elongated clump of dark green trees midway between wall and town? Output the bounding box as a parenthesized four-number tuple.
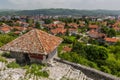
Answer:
(73, 42, 108, 61)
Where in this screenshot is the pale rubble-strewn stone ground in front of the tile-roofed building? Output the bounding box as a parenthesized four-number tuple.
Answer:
(0, 61, 93, 80)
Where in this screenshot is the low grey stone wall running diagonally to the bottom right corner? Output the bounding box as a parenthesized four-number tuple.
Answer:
(54, 58, 120, 80)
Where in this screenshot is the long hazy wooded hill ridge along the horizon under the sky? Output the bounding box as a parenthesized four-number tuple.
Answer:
(0, 9, 120, 16)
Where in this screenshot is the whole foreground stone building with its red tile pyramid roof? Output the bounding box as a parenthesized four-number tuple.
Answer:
(0, 29, 62, 63)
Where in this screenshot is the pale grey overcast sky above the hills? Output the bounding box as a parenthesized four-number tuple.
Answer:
(0, 0, 120, 10)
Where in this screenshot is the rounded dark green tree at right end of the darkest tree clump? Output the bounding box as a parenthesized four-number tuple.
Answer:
(85, 45, 108, 61)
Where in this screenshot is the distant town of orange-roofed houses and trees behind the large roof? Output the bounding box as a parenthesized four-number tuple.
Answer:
(0, 15, 120, 44)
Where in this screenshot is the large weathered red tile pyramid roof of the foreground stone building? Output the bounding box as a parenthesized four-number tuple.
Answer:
(0, 29, 62, 55)
